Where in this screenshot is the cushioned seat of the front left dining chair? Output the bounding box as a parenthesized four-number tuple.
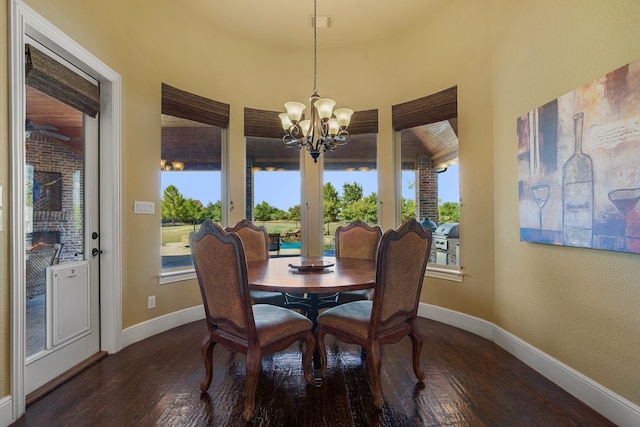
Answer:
(253, 304, 313, 347)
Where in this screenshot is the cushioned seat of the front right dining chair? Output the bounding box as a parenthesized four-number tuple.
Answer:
(318, 301, 373, 339)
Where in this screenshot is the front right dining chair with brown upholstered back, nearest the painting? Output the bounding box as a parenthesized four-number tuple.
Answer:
(316, 219, 432, 408)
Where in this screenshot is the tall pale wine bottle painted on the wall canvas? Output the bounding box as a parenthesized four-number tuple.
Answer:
(562, 113, 593, 248)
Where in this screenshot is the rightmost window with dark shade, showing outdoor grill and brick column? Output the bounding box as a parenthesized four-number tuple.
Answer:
(393, 87, 461, 278)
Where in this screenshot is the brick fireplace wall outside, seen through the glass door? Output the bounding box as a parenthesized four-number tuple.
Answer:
(25, 134, 84, 261)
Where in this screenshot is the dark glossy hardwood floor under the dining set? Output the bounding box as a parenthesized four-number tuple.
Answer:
(14, 319, 613, 427)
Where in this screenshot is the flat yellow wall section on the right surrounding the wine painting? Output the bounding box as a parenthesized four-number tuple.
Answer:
(491, 0, 640, 404)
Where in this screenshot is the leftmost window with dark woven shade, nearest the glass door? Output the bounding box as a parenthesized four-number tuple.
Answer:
(160, 84, 229, 282)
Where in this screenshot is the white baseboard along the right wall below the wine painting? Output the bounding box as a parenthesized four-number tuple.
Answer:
(418, 303, 640, 427)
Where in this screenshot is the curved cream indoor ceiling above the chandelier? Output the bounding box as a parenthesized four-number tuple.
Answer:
(180, 0, 448, 47)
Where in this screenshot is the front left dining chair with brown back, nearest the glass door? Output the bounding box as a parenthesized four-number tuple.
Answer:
(189, 220, 316, 421)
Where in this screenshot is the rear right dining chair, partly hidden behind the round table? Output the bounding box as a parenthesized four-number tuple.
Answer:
(335, 220, 382, 304)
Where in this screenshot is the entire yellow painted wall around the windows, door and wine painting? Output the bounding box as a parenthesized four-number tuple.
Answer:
(0, 0, 640, 410)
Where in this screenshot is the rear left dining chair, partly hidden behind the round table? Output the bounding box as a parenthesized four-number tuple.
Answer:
(225, 219, 285, 307)
